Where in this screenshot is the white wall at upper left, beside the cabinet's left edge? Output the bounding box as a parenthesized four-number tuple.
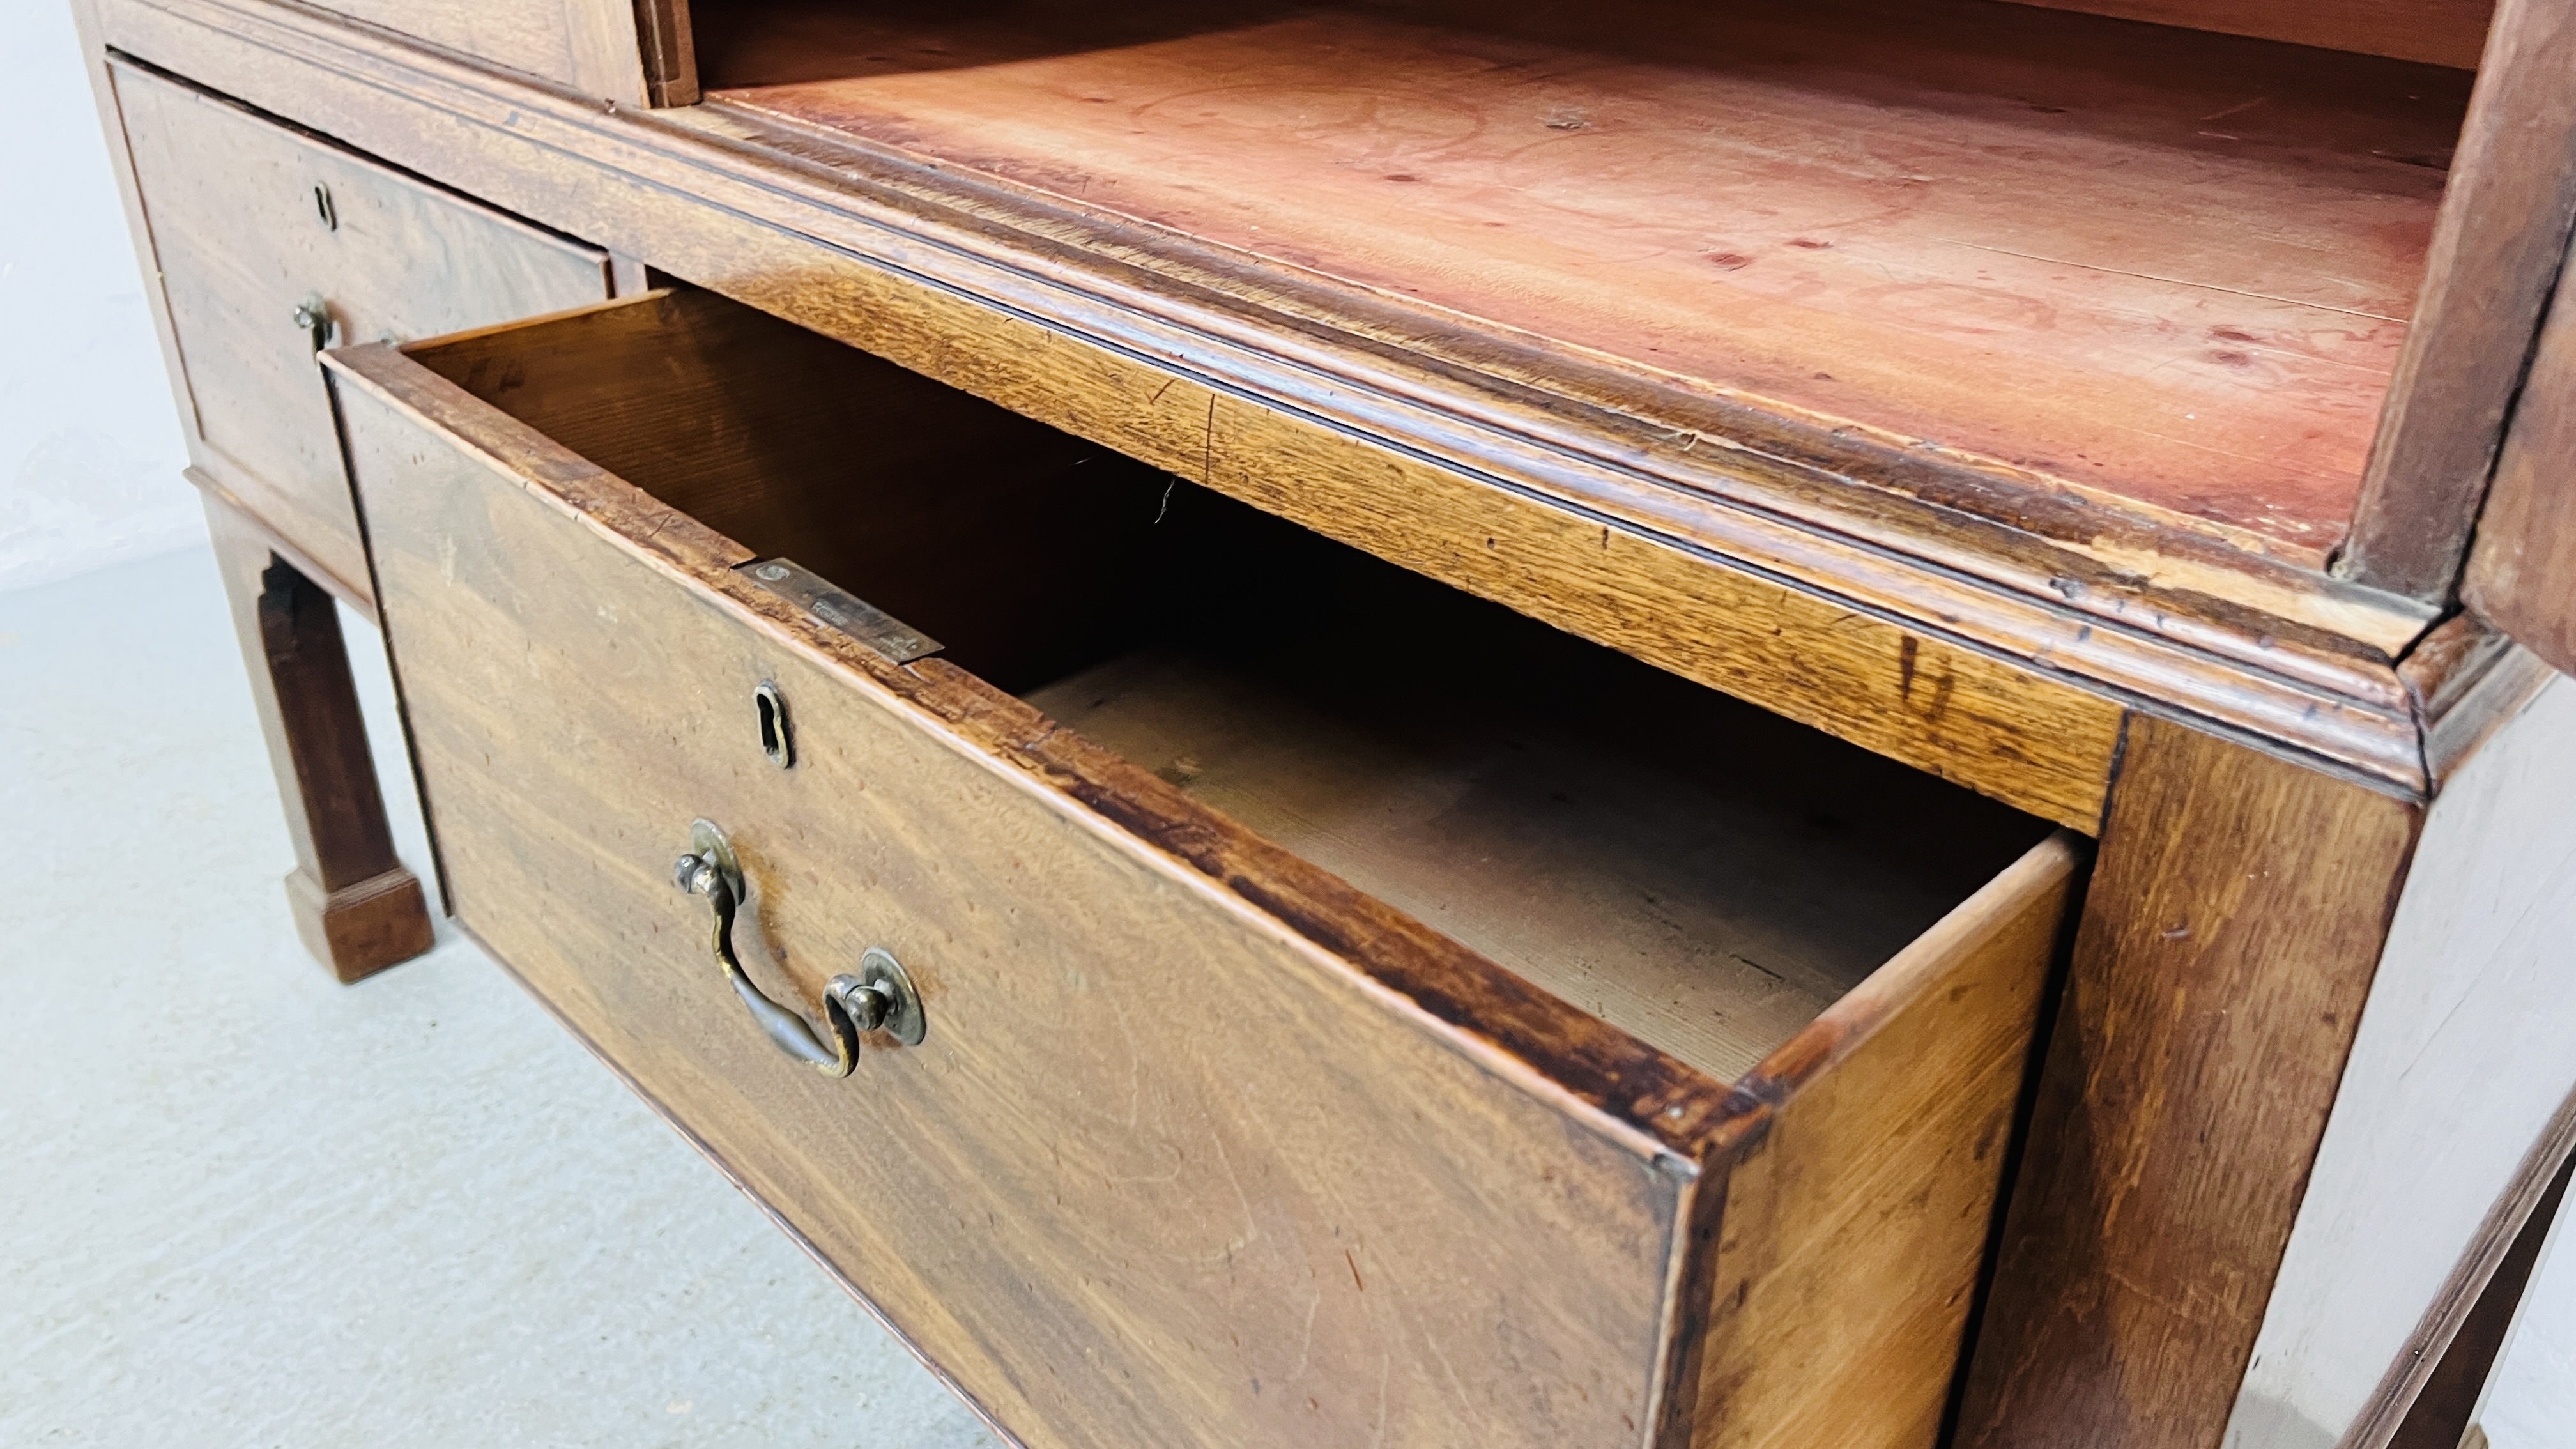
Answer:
(0, 0, 206, 588)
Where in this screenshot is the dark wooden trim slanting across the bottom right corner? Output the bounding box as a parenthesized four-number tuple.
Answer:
(2334, 1072, 2576, 1449)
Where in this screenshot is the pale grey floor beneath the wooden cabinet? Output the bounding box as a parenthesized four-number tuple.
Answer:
(0, 536, 2576, 1449)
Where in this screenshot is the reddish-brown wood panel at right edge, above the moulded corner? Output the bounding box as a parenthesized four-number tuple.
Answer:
(2463, 243, 2576, 673)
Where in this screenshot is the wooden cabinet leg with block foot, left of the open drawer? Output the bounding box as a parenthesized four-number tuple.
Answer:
(206, 495, 430, 983)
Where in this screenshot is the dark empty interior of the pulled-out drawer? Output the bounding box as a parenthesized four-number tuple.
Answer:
(412, 291, 2048, 1080)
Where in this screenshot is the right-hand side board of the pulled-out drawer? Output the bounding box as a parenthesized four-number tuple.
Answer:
(1692, 836, 2079, 1449)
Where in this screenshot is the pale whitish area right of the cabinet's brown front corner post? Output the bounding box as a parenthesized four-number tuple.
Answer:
(2228, 680, 2576, 1449)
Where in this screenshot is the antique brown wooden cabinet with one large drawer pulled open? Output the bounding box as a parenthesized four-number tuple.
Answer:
(77, 0, 2576, 1449)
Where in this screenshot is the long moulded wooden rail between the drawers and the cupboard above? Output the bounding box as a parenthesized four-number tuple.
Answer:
(103, 0, 2432, 799)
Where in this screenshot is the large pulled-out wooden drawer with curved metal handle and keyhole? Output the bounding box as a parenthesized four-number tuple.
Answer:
(327, 291, 2082, 1449)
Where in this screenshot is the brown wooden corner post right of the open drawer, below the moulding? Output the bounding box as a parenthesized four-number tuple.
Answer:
(1958, 714, 2421, 1449)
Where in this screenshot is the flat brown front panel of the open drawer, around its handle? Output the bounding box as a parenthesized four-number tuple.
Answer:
(337, 360, 1692, 1449)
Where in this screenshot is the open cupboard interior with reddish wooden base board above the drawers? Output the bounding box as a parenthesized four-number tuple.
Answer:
(693, 0, 2486, 565)
